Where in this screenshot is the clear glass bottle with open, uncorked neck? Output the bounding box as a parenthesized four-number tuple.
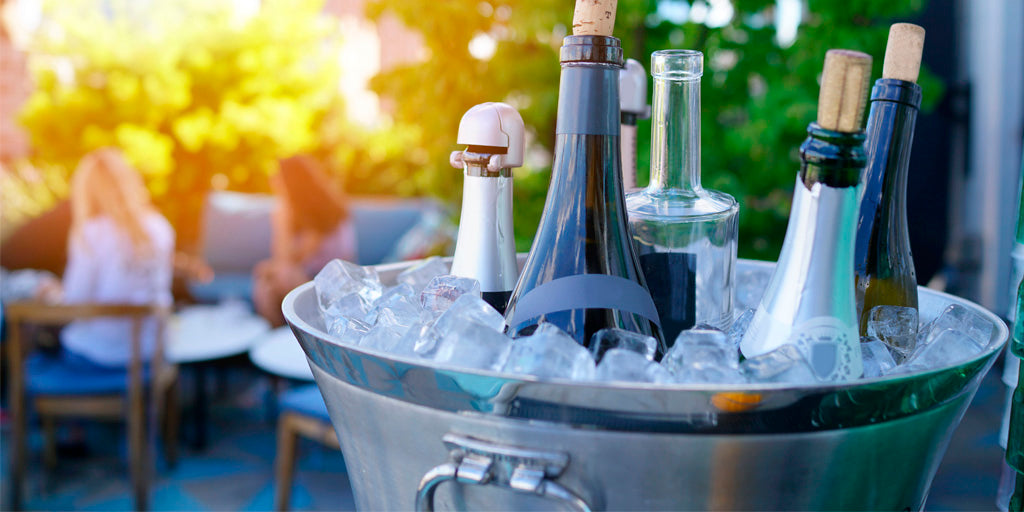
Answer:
(626, 50, 739, 346)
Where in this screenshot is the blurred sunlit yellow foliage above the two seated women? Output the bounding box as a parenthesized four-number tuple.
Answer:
(20, 0, 340, 247)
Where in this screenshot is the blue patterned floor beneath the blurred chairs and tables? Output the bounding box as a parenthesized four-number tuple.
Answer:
(3, 368, 355, 511)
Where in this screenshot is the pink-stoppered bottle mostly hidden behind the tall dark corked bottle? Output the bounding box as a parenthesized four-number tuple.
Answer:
(618, 58, 650, 193)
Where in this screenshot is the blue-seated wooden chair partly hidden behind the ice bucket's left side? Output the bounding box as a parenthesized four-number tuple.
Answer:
(273, 384, 340, 510)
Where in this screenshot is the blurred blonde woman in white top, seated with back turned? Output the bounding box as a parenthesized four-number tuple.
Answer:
(60, 148, 174, 367)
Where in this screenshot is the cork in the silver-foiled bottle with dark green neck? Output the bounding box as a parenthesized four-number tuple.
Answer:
(818, 50, 871, 133)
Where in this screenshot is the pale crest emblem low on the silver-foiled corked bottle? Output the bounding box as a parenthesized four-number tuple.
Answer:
(791, 316, 863, 381)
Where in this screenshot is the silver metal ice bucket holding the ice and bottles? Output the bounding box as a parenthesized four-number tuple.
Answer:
(284, 261, 1008, 510)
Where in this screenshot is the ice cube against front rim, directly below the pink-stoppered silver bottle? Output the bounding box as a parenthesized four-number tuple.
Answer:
(433, 322, 512, 372)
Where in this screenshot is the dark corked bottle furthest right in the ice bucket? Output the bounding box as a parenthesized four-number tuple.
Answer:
(854, 24, 925, 335)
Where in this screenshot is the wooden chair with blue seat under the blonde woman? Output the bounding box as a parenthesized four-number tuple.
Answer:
(4, 302, 178, 510)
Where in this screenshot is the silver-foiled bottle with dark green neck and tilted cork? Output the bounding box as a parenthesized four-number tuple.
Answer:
(739, 50, 871, 381)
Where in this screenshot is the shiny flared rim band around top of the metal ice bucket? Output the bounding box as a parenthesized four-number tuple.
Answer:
(283, 260, 1009, 433)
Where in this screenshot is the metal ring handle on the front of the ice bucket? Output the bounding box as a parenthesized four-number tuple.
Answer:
(416, 433, 591, 512)
